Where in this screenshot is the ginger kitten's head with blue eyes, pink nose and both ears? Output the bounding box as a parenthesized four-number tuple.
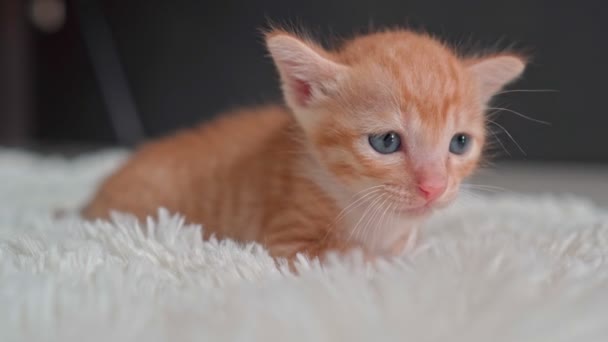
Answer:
(266, 30, 525, 215)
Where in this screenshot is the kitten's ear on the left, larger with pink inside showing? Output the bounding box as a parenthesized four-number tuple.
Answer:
(266, 33, 347, 108)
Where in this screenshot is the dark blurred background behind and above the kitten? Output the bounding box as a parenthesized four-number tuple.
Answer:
(0, 0, 608, 163)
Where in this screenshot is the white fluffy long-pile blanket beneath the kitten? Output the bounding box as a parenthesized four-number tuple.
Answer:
(0, 150, 608, 342)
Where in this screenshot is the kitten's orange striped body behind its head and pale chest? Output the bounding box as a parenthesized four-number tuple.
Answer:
(84, 106, 408, 257)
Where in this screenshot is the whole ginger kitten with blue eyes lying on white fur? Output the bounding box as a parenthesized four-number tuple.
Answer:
(83, 30, 525, 259)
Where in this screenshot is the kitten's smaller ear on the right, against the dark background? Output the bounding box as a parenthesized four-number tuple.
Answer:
(466, 54, 526, 103)
